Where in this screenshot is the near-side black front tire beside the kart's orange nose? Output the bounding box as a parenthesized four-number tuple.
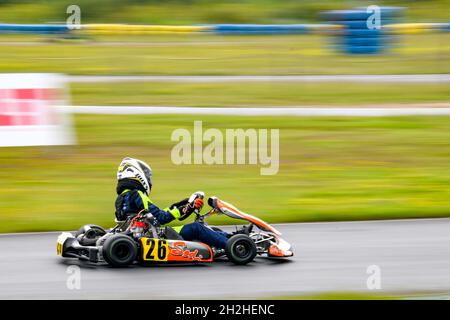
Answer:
(225, 234, 256, 265)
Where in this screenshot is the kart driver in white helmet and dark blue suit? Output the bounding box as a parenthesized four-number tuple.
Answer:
(115, 158, 232, 249)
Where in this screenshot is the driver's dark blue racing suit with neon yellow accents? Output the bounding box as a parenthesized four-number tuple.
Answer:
(115, 182, 230, 249)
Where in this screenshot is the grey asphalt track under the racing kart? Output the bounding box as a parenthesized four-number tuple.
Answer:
(0, 219, 450, 299)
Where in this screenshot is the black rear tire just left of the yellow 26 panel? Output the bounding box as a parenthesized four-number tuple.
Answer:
(102, 234, 138, 267)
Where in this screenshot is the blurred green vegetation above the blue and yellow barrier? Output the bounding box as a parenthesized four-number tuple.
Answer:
(0, 0, 450, 24)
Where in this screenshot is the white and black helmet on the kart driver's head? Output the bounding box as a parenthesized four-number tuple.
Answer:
(117, 157, 152, 194)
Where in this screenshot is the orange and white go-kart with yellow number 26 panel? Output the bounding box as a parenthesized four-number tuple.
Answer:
(56, 192, 293, 267)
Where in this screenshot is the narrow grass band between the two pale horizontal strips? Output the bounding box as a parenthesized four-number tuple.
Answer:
(71, 82, 450, 107)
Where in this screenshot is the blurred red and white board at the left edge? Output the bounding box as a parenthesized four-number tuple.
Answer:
(0, 73, 74, 147)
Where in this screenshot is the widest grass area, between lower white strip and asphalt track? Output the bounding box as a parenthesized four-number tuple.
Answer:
(0, 115, 450, 232)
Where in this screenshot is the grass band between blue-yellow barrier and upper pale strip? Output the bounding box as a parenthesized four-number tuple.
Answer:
(0, 33, 450, 75)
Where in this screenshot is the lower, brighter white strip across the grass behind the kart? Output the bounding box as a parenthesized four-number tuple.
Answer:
(60, 106, 450, 117)
